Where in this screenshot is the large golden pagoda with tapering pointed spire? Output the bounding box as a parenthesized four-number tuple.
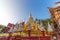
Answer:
(24, 12, 40, 36)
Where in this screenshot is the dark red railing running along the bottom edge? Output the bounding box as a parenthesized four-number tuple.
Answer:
(0, 36, 51, 40)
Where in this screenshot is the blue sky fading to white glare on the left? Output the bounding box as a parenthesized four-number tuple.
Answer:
(0, 0, 59, 25)
